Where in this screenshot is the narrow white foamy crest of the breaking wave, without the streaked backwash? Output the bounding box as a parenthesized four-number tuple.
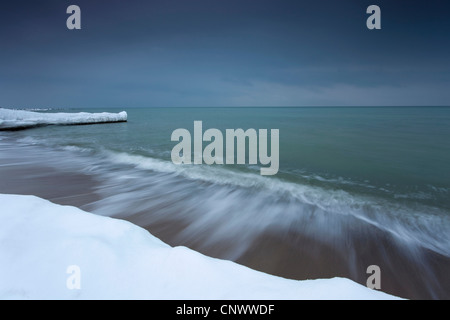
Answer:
(103, 151, 450, 256)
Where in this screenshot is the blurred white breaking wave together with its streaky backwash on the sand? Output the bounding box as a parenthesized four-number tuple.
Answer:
(2, 138, 450, 293)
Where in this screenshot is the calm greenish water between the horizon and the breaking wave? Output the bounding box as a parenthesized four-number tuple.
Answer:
(10, 107, 450, 209)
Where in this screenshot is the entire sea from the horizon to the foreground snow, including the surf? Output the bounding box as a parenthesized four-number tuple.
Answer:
(0, 106, 450, 299)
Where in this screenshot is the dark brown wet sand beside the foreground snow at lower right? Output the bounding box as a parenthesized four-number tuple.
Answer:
(146, 210, 450, 300)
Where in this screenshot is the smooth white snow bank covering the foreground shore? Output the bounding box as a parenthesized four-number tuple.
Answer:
(0, 195, 396, 300)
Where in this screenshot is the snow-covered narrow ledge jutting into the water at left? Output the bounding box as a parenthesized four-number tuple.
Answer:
(0, 108, 127, 130)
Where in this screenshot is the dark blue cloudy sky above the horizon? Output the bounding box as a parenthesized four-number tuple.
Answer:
(0, 0, 450, 108)
